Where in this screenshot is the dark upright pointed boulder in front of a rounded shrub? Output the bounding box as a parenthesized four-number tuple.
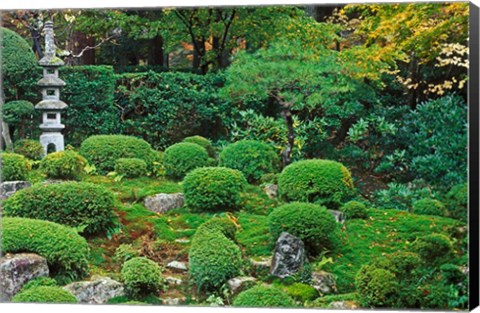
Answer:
(270, 232, 305, 278)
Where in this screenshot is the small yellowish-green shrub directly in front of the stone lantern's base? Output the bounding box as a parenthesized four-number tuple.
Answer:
(40, 150, 87, 180)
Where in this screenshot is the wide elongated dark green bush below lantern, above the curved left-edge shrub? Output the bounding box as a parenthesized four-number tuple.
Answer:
(4, 182, 115, 234)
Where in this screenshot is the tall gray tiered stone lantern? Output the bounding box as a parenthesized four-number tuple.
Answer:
(35, 21, 68, 153)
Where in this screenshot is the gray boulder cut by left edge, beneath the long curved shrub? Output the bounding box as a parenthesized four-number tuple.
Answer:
(0, 253, 49, 302)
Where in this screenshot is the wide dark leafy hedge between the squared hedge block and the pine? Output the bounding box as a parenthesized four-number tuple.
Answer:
(115, 71, 225, 150)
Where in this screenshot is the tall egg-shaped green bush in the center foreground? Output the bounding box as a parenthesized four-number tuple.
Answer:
(188, 217, 242, 291)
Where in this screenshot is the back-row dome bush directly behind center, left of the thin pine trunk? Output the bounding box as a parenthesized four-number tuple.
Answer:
(219, 140, 280, 183)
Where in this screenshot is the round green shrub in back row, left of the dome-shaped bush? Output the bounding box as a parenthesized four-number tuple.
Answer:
(163, 142, 208, 179)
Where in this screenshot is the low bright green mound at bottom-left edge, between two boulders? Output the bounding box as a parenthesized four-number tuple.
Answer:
(12, 286, 77, 303)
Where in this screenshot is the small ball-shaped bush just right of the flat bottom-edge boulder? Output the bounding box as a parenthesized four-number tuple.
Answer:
(121, 257, 164, 297)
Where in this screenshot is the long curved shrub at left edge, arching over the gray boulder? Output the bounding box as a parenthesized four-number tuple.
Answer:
(1, 217, 89, 280)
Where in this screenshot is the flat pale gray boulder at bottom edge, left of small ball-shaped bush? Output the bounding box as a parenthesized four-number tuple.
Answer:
(63, 276, 125, 304)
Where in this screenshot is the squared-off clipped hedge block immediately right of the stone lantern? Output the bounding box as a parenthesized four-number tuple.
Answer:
(59, 65, 123, 146)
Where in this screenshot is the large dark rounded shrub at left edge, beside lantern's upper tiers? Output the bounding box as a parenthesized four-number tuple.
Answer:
(0, 27, 41, 102)
